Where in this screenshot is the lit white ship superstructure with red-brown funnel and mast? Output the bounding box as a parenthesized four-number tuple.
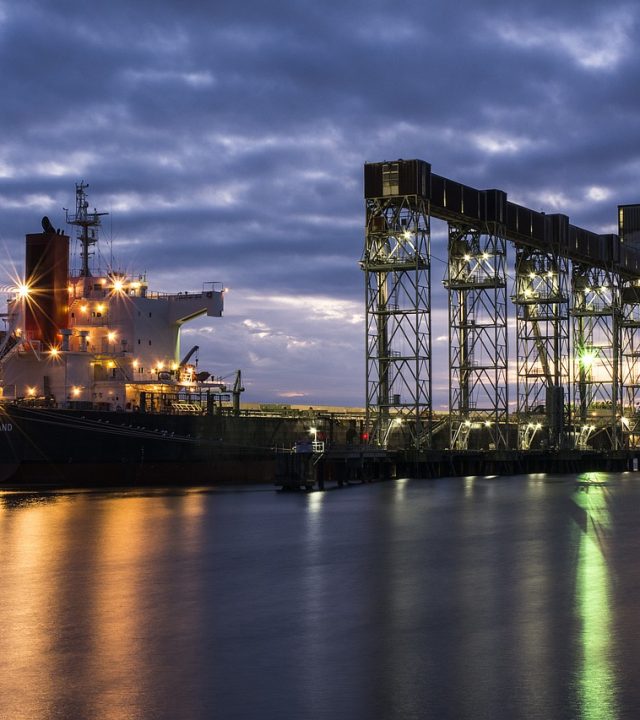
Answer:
(0, 183, 224, 412)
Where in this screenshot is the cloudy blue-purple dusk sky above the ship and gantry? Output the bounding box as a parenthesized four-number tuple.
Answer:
(0, 0, 640, 405)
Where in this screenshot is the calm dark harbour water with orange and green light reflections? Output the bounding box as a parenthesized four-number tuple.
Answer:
(0, 474, 640, 720)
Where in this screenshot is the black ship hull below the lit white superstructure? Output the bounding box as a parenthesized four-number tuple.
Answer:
(0, 404, 308, 487)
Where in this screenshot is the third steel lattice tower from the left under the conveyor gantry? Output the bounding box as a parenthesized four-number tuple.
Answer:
(512, 247, 570, 450)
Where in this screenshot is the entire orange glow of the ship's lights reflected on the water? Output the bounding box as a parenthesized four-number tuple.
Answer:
(0, 493, 204, 720)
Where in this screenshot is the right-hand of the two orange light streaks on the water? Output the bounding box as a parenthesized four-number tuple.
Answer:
(91, 494, 204, 720)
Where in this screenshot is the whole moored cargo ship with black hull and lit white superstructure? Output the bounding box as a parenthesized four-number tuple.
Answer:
(0, 182, 320, 486)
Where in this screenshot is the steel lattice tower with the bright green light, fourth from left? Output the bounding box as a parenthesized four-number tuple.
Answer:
(571, 263, 622, 450)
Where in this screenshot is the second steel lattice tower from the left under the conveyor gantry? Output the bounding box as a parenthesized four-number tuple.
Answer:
(444, 222, 509, 450)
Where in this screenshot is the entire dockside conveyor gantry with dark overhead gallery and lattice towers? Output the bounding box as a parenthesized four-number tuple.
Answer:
(362, 160, 640, 451)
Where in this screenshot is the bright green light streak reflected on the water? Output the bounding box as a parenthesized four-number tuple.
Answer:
(573, 473, 618, 720)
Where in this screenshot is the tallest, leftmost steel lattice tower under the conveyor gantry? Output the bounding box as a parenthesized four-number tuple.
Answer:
(361, 195, 432, 449)
